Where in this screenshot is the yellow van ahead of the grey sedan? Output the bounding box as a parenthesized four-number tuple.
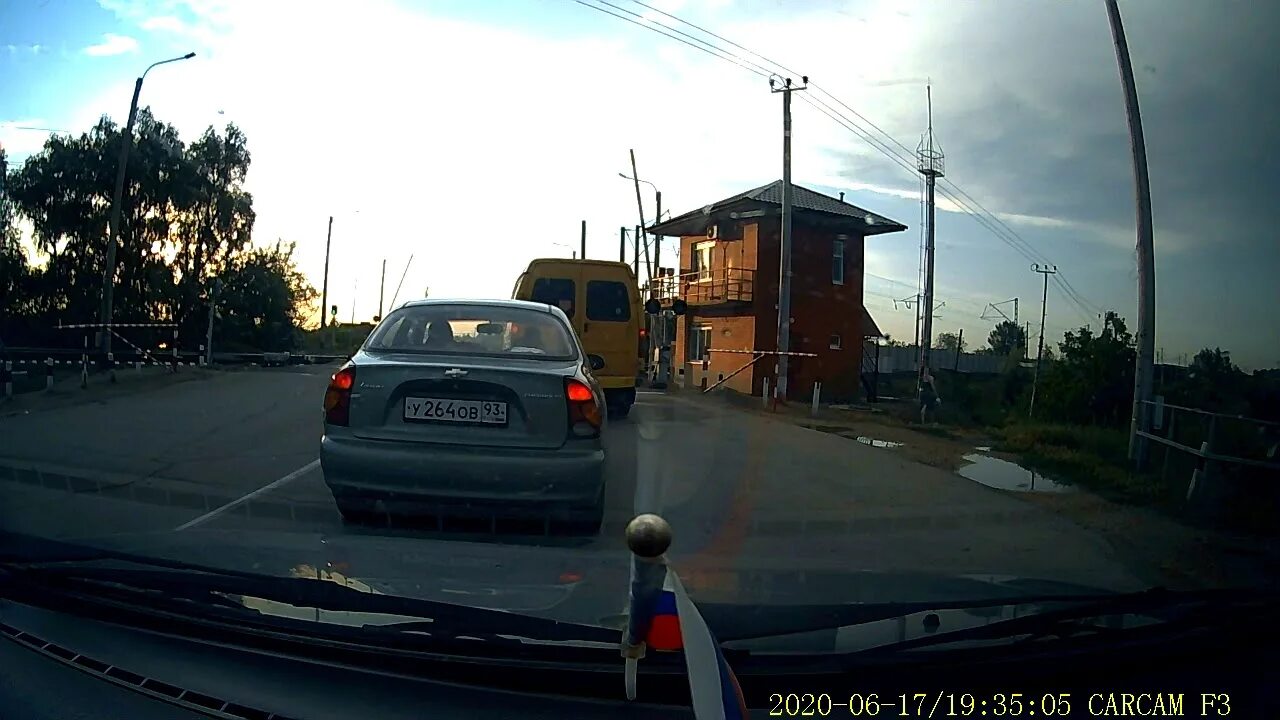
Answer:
(512, 258, 644, 418)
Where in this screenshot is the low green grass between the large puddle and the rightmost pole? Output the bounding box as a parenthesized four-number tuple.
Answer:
(996, 424, 1170, 505)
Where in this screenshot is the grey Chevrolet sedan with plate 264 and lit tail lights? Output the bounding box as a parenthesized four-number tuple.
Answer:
(320, 300, 605, 532)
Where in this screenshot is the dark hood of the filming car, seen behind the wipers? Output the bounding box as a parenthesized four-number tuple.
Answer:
(5, 520, 1136, 652)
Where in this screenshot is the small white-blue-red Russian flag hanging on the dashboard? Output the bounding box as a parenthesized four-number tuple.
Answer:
(629, 568, 746, 720)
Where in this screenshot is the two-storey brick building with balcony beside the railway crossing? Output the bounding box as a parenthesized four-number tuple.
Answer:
(649, 181, 906, 401)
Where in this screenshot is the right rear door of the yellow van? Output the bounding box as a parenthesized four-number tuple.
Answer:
(580, 273, 640, 387)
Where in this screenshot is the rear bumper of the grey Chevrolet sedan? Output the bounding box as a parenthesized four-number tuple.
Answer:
(320, 433, 604, 515)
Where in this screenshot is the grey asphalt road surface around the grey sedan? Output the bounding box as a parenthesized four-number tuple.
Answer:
(0, 366, 1149, 618)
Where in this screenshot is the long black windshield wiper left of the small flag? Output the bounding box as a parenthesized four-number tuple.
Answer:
(0, 551, 620, 643)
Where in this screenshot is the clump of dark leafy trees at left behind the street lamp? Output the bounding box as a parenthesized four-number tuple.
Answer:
(0, 108, 304, 348)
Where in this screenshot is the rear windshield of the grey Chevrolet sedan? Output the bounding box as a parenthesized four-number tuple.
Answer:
(365, 304, 577, 360)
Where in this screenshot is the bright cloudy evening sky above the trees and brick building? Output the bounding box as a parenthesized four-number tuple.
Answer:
(0, 0, 1280, 369)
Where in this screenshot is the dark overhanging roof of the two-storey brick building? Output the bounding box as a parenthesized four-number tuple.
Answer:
(649, 181, 906, 236)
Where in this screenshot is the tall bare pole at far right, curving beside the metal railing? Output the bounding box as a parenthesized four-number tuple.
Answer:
(1105, 0, 1156, 465)
